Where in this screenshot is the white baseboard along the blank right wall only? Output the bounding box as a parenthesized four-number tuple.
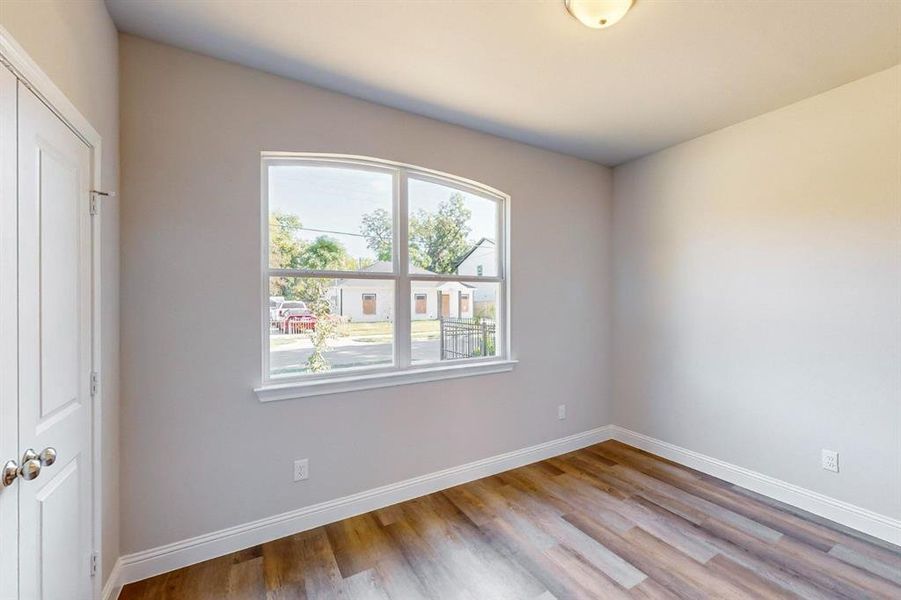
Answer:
(610, 425, 901, 546)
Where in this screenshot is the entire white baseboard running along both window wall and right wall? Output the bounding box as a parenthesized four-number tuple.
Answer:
(103, 425, 901, 600)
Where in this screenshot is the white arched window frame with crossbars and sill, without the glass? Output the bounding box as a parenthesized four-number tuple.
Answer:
(254, 152, 517, 402)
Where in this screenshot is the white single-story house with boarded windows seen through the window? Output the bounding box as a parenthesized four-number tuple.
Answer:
(331, 262, 476, 323)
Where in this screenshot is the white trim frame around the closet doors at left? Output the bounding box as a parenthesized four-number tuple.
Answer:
(0, 25, 103, 598)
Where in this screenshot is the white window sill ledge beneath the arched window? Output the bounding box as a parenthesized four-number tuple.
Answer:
(254, 360, 519, 402)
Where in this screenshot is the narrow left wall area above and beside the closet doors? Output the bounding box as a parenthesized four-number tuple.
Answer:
(0, 0, 119, 580)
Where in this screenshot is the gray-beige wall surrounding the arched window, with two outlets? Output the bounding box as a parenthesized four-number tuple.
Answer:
(120, 35, 612, 553)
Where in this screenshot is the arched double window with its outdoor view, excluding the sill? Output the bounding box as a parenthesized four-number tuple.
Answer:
(263, 157, 506, 380)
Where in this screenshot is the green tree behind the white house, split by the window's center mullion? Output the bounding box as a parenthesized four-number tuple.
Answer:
(360, 193, 472, 273)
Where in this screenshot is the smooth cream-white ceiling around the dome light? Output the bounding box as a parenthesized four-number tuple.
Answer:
(107, 0, 901, 165)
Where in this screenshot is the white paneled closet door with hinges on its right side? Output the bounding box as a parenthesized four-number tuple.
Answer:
(16, 83, 92, 600)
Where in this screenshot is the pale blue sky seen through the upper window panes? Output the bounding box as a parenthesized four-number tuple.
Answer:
(269, 166, 496, 258)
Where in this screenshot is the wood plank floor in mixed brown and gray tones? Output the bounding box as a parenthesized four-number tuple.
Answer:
(120, 442, 901, 600)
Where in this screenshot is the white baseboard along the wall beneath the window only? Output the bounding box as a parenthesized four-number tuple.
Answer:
(103, 426, 610, 600)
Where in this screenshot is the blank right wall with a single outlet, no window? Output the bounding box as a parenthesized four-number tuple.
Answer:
(613, 67, 901, 518)
